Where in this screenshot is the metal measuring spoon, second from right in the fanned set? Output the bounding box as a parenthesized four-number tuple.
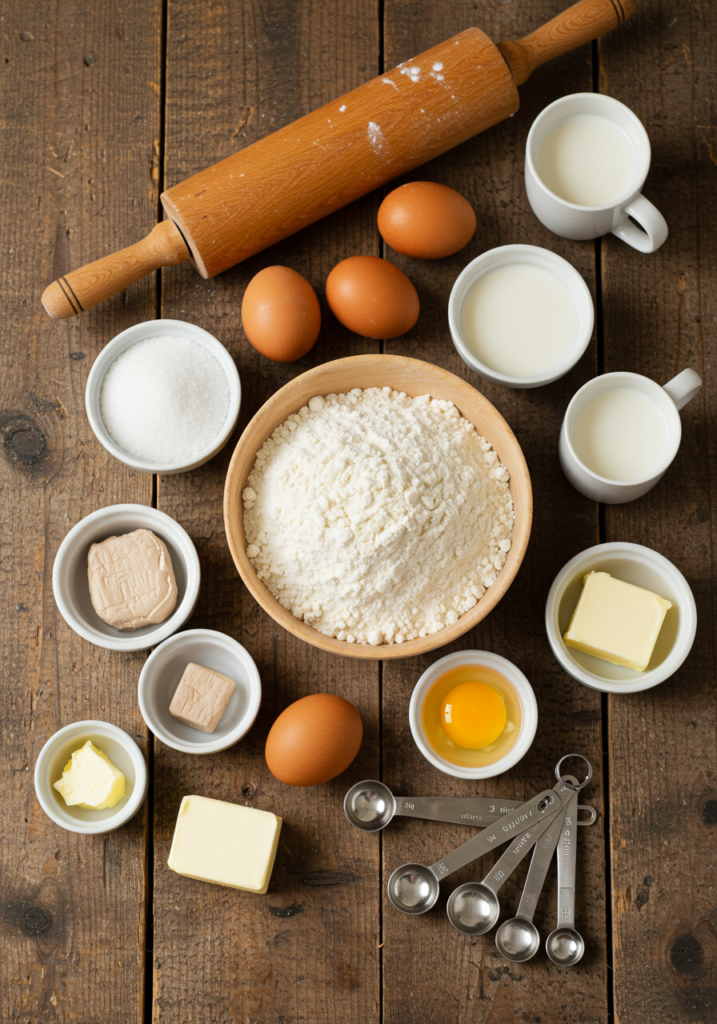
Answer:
(496, 775, 581, 964)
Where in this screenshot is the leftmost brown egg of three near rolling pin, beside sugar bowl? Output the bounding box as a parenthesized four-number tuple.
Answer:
(242, 266, 322, 362)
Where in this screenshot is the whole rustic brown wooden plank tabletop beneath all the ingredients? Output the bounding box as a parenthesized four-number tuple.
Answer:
(0, 0, 717, 1024)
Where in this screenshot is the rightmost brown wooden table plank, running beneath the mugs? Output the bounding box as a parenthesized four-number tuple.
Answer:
(600, 0, 717, 1024)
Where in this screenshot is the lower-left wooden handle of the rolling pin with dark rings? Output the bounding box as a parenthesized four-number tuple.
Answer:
(42, 220, 189, 319)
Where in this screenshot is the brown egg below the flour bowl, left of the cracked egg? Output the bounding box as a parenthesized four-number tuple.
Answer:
(265, 693, 364, 785)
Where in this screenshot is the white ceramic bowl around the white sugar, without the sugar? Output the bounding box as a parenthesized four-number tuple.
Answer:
(85, 319, 242, 473)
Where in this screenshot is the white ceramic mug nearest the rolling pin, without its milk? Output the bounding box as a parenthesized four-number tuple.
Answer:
(525, 92, 668, 253)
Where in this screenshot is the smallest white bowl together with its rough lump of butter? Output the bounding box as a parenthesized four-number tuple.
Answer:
(35, 721, 147, 836)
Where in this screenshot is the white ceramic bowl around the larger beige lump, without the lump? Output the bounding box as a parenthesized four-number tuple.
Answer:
(52, 505, 200, 650)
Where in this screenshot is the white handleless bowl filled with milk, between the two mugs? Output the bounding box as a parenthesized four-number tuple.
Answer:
(449, 245, 595, 388)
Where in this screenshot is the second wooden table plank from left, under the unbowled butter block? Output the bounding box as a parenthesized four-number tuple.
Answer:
(154, 0, 379, 1024)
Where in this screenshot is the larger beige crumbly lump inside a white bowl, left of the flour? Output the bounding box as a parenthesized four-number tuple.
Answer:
(87, 529, 177, 630)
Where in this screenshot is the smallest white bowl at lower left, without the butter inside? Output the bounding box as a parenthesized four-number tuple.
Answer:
(35, 721, 147, 836)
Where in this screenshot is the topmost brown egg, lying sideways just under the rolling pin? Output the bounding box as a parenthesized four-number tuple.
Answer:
(378, 181, 475, 259)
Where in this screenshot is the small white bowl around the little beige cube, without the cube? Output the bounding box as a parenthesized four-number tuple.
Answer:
(137, 630, 261, 754)
